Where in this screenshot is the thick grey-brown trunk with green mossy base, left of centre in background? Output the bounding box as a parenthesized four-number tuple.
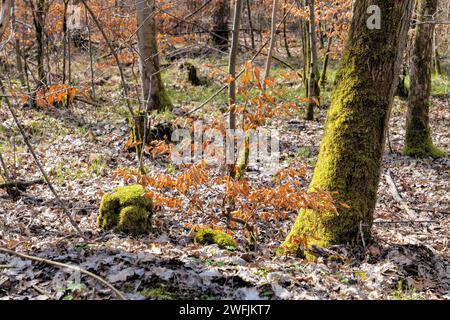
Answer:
(136, 0, 172, 111)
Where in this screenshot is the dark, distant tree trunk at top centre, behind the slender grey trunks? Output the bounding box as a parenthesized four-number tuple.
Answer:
(212, 0, 230, 50)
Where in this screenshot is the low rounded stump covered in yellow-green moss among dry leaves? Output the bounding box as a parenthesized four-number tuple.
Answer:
(97, 185, 153, 235)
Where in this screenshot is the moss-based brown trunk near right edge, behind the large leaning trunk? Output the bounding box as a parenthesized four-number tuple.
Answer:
(404, 0, 444, 158)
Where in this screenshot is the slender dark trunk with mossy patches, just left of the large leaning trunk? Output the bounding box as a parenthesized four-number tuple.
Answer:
(306, 0, 320, 120)
